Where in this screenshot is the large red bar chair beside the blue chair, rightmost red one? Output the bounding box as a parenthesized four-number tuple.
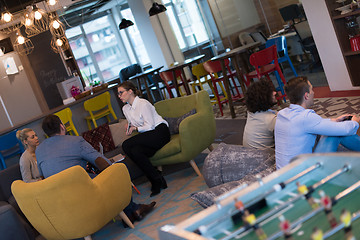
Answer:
(245, 45, 286, 101)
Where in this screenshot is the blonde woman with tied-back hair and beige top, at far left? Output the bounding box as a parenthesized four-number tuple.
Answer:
(16, 128, 43, 183)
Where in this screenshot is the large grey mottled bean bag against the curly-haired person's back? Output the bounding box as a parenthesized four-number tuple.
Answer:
(202, 143, 275, 187)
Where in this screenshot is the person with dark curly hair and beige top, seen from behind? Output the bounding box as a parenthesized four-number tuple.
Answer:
(243, 79, 276, 149)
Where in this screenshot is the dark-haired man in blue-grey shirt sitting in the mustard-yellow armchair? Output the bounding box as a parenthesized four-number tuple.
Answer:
(36, 115, 156, 225)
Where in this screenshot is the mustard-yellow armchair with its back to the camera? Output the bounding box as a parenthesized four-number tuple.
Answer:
(11, 163, 134, 239)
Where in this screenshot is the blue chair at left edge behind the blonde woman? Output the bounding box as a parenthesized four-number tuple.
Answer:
(0, 130, 25, 169)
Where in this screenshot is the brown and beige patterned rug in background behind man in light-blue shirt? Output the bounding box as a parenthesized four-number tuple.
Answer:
(213, 97, 360, 119)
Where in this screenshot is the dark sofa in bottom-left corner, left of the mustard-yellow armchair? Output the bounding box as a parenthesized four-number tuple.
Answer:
(0, 164, 37, 240)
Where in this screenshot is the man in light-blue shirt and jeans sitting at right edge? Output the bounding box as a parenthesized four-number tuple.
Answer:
(275, 77, 360, 169)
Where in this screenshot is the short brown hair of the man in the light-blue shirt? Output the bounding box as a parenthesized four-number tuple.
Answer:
(285, 76, 310, 104)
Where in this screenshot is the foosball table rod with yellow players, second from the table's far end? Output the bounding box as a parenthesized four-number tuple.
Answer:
(221, 164, 350, 240)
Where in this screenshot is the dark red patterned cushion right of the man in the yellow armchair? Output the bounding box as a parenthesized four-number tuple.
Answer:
(82, 123, 115, 153)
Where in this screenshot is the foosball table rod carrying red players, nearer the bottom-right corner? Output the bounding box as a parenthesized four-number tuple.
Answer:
(267, 181, 360, 240)
